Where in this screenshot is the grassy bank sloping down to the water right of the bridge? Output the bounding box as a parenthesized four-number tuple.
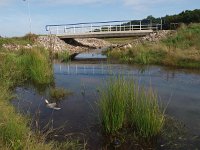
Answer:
(107, 24, 200, 68)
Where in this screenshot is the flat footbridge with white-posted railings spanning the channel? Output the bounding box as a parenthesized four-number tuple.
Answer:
(46, 20, 162, 39)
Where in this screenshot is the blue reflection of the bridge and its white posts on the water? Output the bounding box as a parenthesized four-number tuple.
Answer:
(54, 63, 149, 76)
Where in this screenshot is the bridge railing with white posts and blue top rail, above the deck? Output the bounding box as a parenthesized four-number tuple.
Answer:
(46, 20, 162, 35)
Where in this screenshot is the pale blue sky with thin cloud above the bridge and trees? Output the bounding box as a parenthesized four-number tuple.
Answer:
(0, 0, 200, 37)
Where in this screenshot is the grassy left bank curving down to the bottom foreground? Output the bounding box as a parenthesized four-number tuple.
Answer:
(0, 43, 81, 150)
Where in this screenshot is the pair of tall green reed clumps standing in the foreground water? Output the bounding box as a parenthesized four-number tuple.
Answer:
(99, 76, 164, 139)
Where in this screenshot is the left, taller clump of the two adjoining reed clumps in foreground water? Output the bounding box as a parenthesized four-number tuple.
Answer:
(99, 77, 128, 134)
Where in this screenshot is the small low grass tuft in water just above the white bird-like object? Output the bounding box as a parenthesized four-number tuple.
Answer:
(50, 88, 72, 101)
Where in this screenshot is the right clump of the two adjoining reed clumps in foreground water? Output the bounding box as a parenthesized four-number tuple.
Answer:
(130, 88, 164, 139)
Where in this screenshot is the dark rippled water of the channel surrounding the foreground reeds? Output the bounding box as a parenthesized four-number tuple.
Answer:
(13, 52, 200, 150)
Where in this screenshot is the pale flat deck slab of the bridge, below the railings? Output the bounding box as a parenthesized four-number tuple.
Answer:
(57, 30, 153, 39)
